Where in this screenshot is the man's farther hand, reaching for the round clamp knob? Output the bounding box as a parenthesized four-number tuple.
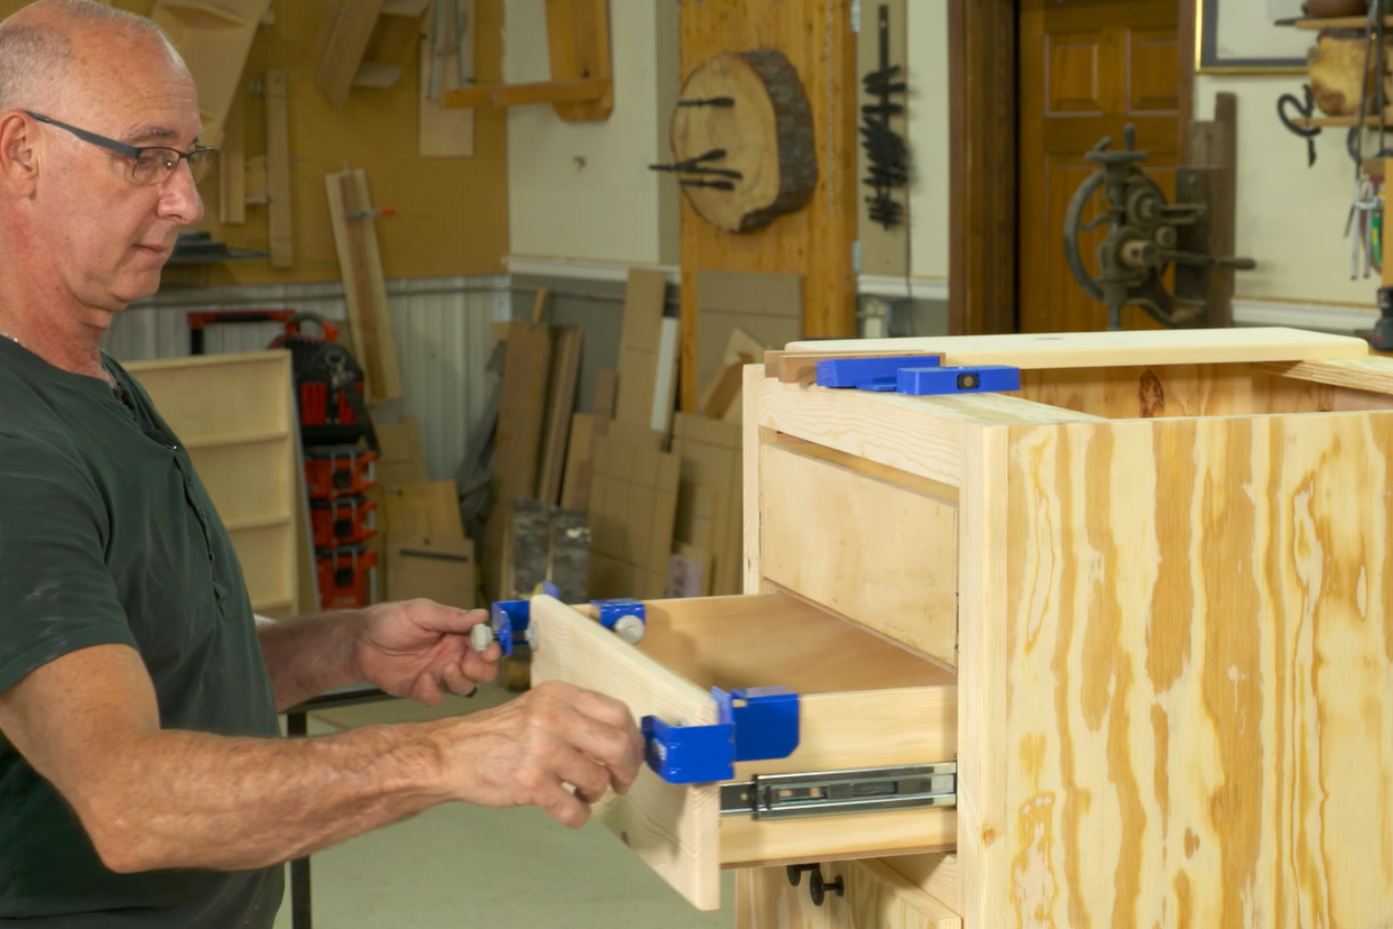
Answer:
(354, 600, 501, 706)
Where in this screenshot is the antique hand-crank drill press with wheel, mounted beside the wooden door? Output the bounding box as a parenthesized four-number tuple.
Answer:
(1064, 124, 1256, 329)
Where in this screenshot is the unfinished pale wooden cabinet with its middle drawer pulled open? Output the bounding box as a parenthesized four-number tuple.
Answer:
(534, 330, 1393, 929)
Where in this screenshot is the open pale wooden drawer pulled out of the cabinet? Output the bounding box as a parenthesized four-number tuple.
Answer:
(531, 593, 957, 910)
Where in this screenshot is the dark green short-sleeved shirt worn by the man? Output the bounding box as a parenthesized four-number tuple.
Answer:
(0, 337, 283, 929)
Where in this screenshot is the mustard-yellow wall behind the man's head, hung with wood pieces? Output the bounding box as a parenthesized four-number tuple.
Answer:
(0, 0, 509, 284)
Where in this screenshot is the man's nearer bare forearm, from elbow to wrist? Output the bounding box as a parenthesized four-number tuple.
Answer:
(91, 723, 450, 871)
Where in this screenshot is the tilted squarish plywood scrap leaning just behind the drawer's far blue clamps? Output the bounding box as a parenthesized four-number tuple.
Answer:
(591, 439, 681, 599)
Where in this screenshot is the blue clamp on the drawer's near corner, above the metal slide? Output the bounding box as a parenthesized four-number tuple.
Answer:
(641, 687, 798, 784)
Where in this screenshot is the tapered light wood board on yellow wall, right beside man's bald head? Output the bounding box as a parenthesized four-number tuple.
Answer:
(150, 0, 270, 148)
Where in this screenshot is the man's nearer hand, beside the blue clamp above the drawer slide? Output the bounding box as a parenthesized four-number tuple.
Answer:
(435, 681, 644, 829)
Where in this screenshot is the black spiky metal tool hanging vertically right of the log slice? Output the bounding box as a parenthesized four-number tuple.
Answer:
(861, 4, 910, 228)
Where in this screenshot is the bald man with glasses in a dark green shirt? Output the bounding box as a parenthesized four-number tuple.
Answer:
(0, 0, 642, 929)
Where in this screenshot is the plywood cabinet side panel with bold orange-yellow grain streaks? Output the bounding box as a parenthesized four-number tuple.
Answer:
(1002, 412, 1393, 926)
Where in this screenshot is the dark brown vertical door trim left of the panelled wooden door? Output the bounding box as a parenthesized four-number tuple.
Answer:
(949, 0, 1017, 336)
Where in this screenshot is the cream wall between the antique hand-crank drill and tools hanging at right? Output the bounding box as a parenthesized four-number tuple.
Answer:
(1195, 74, 1379, 309)
